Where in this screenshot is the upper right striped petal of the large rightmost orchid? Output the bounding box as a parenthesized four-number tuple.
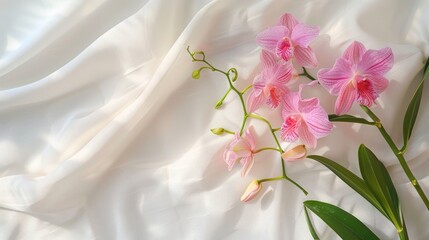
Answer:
(358, 48, 393, 76)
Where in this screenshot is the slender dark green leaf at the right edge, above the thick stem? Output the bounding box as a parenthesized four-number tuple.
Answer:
(402, 58, 429, 150)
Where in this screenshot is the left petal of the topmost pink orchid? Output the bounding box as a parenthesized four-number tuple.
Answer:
(256, 26, 289, 51)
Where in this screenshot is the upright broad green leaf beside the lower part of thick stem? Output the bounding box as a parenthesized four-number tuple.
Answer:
(358, 144, 403, 231)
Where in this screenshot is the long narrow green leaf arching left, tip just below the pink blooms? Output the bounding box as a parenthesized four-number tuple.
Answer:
(307, 155, 389, 218)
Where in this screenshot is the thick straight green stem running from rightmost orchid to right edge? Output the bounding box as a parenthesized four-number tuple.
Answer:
(361, 105, 429, 210)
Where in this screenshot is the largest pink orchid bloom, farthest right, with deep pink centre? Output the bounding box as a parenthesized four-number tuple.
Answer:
(317, 41, 393, 115)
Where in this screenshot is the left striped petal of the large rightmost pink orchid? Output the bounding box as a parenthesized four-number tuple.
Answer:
(317, 58, 353, 96)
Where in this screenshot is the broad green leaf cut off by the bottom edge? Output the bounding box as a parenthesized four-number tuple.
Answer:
(304, 200, 380, 240)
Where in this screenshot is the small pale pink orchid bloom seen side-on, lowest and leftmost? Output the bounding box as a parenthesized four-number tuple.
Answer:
(223, 126, 255, 177)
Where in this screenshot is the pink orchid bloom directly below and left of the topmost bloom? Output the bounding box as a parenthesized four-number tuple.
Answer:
(247, 50, 292, 112)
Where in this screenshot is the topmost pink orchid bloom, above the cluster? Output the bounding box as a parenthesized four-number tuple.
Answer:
(256, 13, 319, 67)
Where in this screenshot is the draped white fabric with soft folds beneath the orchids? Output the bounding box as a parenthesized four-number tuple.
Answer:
(0, 0, 429, 240)
